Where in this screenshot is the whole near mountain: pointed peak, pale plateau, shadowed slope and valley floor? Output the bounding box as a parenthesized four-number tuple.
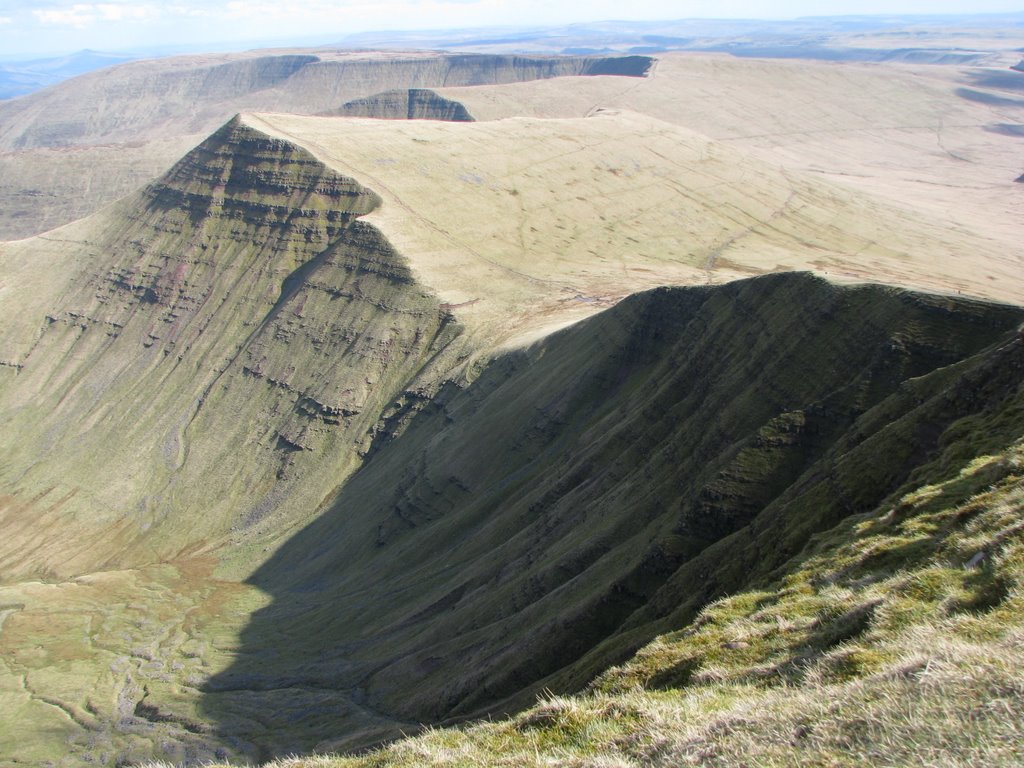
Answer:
(0, 88, 1024, 765)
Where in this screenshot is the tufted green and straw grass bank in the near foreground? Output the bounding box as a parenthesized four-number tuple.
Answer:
(146, 434, 1024, 768)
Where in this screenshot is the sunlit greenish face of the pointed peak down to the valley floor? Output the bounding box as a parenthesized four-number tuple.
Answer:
(0, 123, 468, 765)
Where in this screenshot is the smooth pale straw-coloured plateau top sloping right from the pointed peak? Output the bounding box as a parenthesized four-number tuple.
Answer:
(245, 107, 1024, 348)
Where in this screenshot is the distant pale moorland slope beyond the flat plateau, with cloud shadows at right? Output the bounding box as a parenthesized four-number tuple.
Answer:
(439, 53, 1024, 268)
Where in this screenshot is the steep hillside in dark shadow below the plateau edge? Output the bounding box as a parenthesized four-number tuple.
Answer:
(204, 274, 1024, 758)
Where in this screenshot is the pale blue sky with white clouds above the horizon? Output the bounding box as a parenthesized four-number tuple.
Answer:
(0, 0, 1024, 58)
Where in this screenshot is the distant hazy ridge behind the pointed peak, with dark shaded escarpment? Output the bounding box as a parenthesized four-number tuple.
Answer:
(0, 48, 651, 239)
